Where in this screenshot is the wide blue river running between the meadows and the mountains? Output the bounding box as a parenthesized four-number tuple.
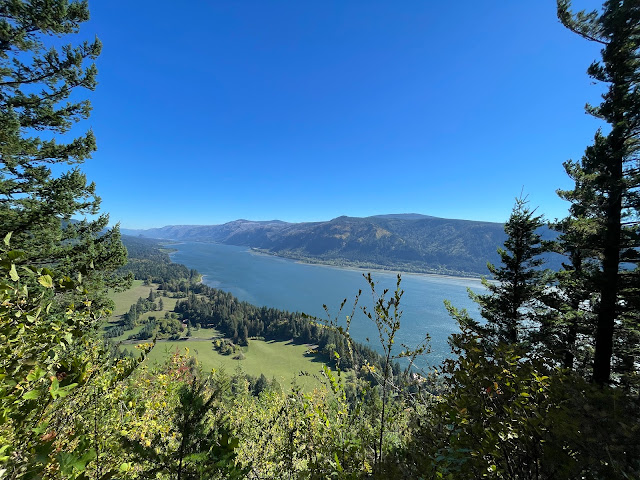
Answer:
(171, 242, 485, 366)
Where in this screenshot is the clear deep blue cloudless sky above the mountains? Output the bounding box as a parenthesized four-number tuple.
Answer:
(76, 0, 602, 228)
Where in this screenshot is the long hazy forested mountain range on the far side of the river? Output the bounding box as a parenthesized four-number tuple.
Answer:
(122, 214, 552, 276)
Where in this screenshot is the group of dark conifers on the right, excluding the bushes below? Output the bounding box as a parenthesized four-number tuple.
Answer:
(452, 0, 640, 393)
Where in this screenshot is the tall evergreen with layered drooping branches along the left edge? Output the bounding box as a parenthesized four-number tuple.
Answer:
(0, 0, 126, 306)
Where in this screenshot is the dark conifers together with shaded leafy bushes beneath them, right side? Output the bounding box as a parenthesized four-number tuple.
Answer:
(404, 0, 640, 478)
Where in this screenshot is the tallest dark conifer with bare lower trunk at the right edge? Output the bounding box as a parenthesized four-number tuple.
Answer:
(558, 0, 640, 384)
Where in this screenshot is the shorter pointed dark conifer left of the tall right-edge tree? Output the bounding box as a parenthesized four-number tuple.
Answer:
(472, 198, 545, 346)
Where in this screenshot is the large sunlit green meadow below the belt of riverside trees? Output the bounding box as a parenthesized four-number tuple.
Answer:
(123, 336, 322, 391)
